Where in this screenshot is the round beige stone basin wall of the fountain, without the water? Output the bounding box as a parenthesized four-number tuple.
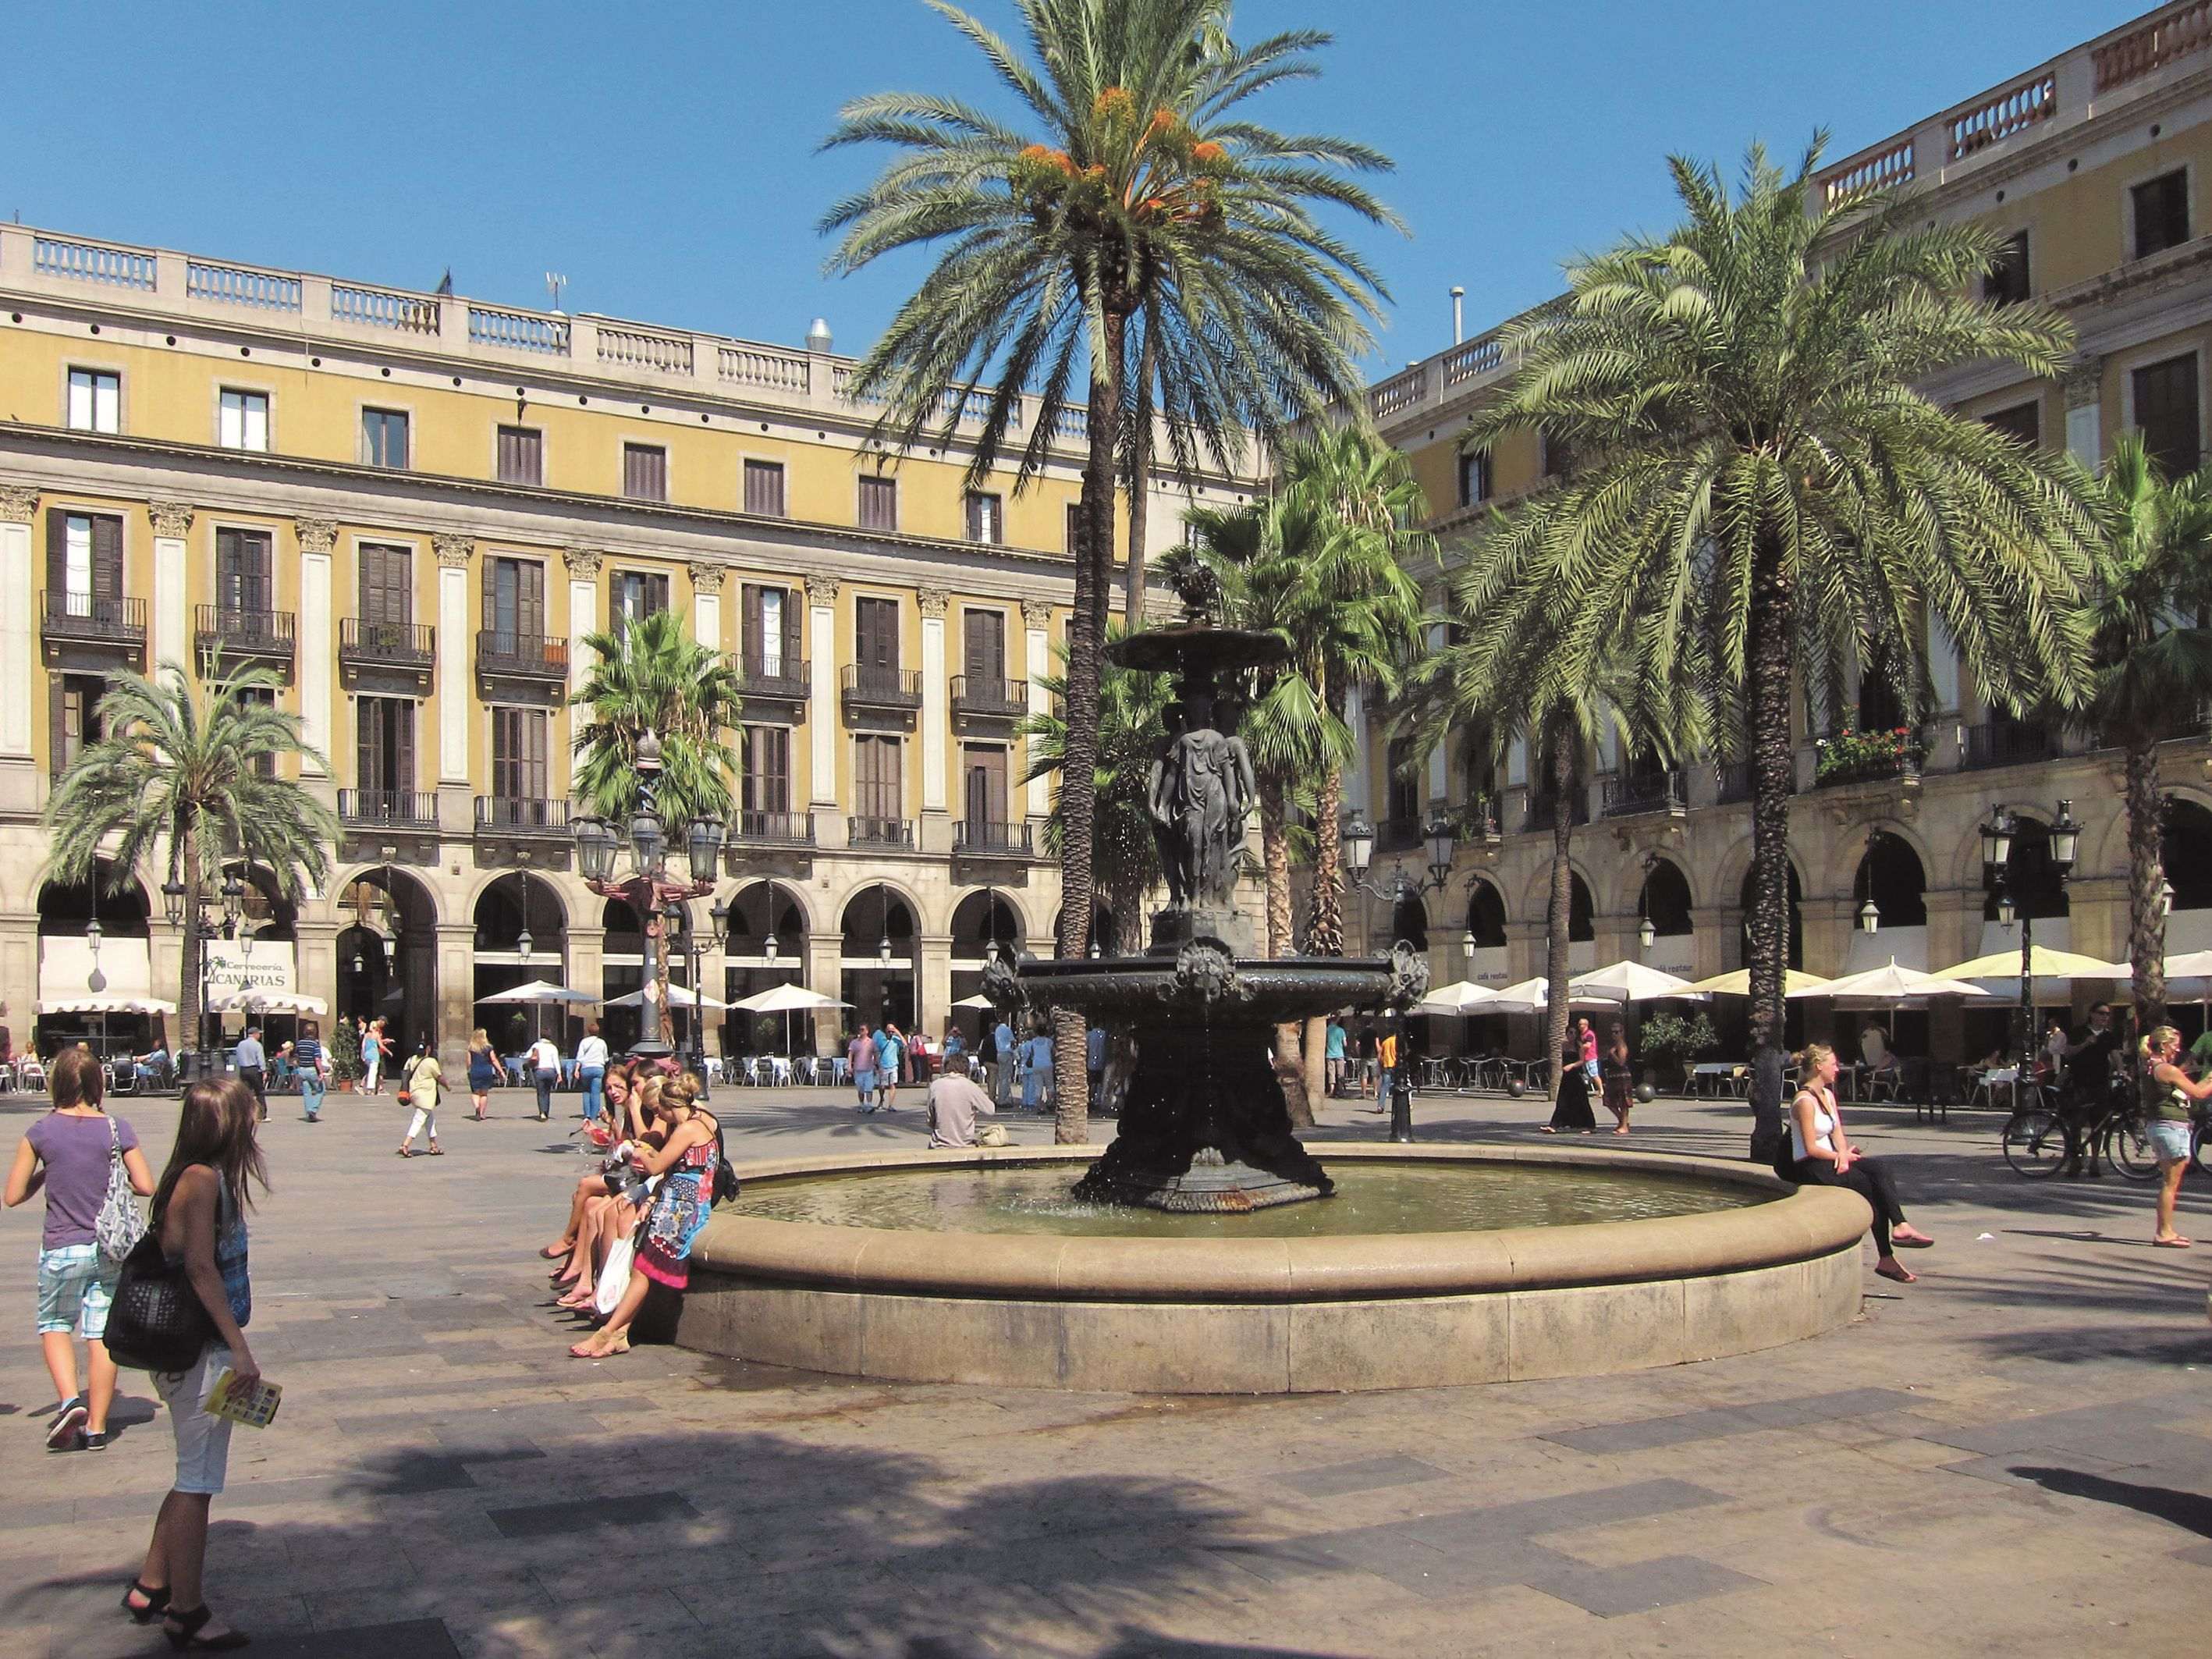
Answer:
(677, 1144, 1871, 1394)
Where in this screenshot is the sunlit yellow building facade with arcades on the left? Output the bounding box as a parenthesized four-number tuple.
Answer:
(0, 226, 1250, 1055)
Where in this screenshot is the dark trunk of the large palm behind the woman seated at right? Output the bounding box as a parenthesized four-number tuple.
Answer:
(1745, 531, 1796, 1163)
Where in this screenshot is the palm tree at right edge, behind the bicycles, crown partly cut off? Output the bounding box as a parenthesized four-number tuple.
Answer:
(2079, 432, 2212, 1031)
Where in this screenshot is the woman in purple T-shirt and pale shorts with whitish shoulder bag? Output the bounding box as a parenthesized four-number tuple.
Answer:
(5, 1049, 153, 1451)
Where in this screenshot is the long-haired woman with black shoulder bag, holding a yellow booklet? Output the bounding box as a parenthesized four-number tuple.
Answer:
(124, 1077, 270, 1652)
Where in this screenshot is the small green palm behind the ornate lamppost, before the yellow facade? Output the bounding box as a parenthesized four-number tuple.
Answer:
(569, 610, 739, 1042)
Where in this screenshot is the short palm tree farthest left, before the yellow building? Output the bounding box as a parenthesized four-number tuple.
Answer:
(47, 659, 339, 1066)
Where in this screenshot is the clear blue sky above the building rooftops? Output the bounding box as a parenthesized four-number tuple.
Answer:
(0, 0, 2148, 369)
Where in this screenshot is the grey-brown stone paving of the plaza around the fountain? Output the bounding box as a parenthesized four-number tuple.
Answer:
(0, 1090, 2212, 1659)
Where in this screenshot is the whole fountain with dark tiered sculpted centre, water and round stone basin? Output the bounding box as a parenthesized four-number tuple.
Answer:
(677, 567, 1869, 1394)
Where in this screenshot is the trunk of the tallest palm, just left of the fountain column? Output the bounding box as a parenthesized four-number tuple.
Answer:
(1053, 305, 1128, 1146)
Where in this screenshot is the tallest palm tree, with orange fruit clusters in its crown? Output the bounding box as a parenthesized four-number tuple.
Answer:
(823, 0, 1396, 1132)
